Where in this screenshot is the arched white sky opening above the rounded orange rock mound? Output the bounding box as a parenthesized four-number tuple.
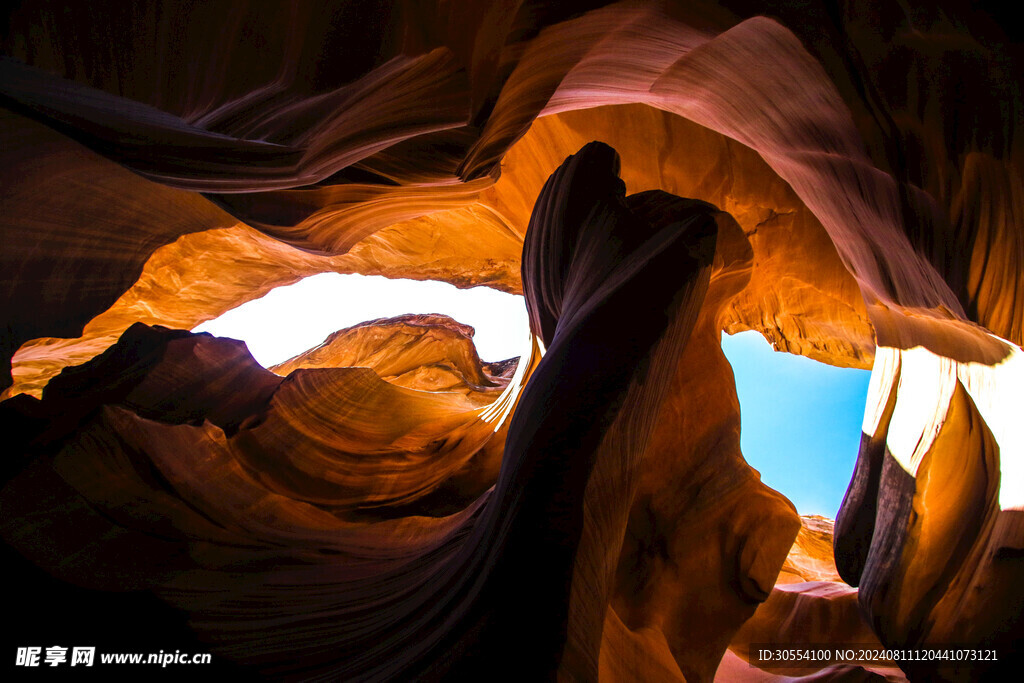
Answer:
(195, 272, 529, 368)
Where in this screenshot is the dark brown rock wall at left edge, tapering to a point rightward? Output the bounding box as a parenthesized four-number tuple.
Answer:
(0, 110, 237, 393)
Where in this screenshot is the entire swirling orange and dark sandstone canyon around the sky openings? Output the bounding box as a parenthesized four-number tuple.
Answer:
(0, 0, 1024, 681)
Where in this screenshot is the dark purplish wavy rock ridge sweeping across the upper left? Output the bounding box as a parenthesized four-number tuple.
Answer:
(0, 48, 468, 193)
